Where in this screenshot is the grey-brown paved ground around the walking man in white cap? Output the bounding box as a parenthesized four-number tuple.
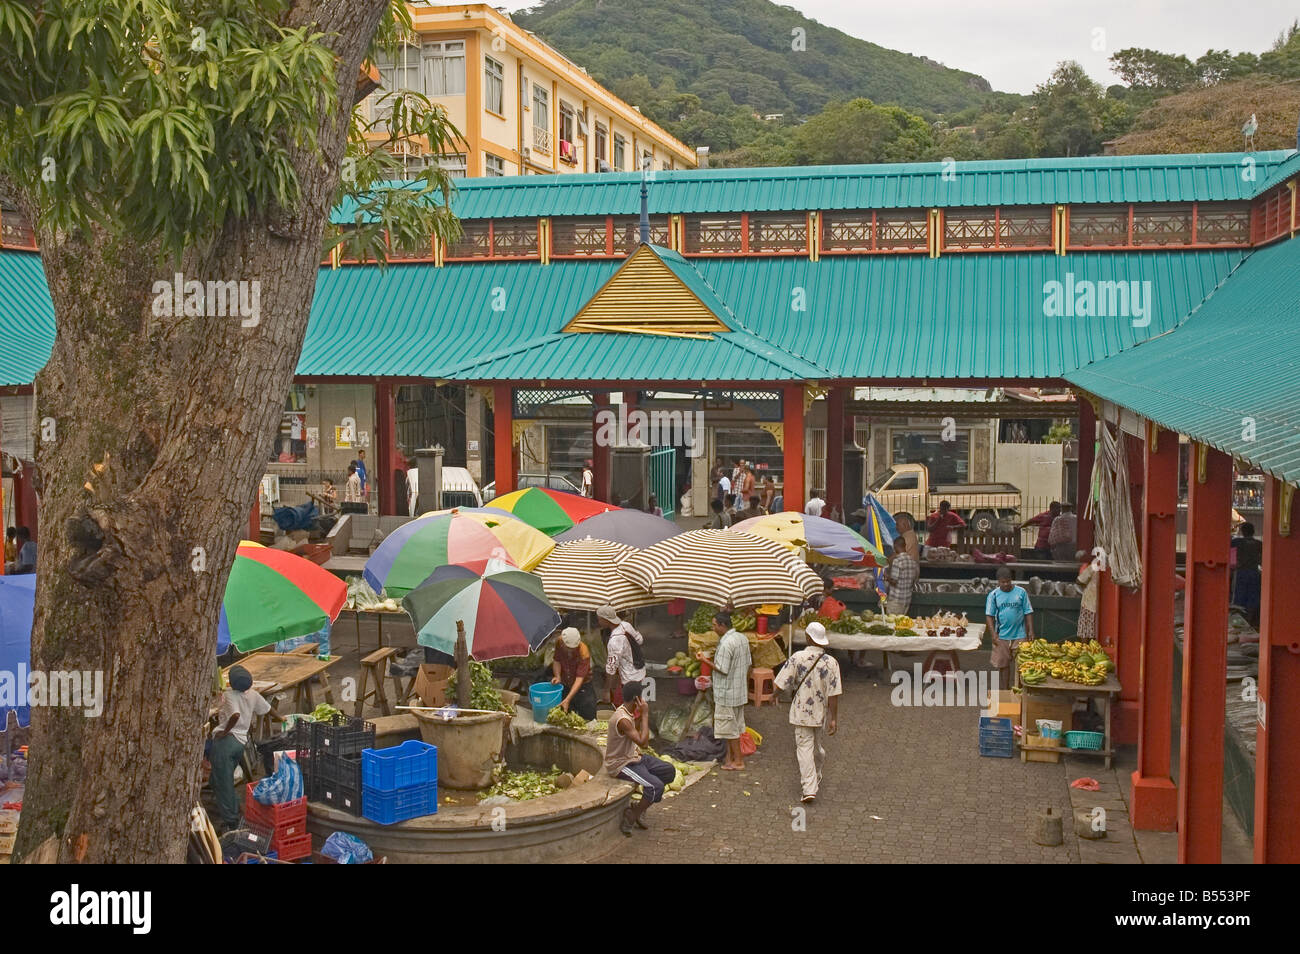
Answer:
(598, 668, 1079, 863)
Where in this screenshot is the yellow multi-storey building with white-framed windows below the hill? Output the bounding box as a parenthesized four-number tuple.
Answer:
(367, 4, 696, 175)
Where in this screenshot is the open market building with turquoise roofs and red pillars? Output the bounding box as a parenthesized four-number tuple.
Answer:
(0, 151, 1300, 862)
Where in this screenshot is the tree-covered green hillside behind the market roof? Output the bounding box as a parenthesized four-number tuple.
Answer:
(514, 0, 1300, 166)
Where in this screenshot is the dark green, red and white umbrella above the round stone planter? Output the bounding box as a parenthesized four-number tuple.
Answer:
(402, 560, 560, 662)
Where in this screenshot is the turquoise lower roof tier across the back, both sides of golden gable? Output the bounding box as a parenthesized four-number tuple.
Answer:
(0, 251, 1243, 383)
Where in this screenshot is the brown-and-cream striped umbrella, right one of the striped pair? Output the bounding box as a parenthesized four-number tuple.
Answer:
(619, 530, 823, 608)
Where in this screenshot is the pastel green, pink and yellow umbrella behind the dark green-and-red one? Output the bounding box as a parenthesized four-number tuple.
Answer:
(364, 511, 555, 599)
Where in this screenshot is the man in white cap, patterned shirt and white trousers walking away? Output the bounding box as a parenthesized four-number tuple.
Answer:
(776, 623, 844, 803)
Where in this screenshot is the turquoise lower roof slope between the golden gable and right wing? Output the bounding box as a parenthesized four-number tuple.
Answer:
(693, 252, 1242, 378)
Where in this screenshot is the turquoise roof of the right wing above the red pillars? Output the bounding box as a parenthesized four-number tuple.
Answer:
(1066, 232, 1300, 483)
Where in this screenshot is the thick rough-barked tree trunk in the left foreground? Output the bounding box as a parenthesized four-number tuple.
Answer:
(16, 0, 389, 863)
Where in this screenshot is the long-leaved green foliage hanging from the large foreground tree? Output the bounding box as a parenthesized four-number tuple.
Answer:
(0, 0, 459, 265)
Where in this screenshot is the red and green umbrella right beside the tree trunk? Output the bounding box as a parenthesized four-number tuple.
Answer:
(217, 539, 347, 654)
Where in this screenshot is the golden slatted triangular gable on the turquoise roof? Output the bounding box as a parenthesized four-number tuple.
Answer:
(564, 246, 731, 337)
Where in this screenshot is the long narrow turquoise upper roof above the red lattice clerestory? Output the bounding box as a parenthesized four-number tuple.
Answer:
(333, 149, 1296, 224)
